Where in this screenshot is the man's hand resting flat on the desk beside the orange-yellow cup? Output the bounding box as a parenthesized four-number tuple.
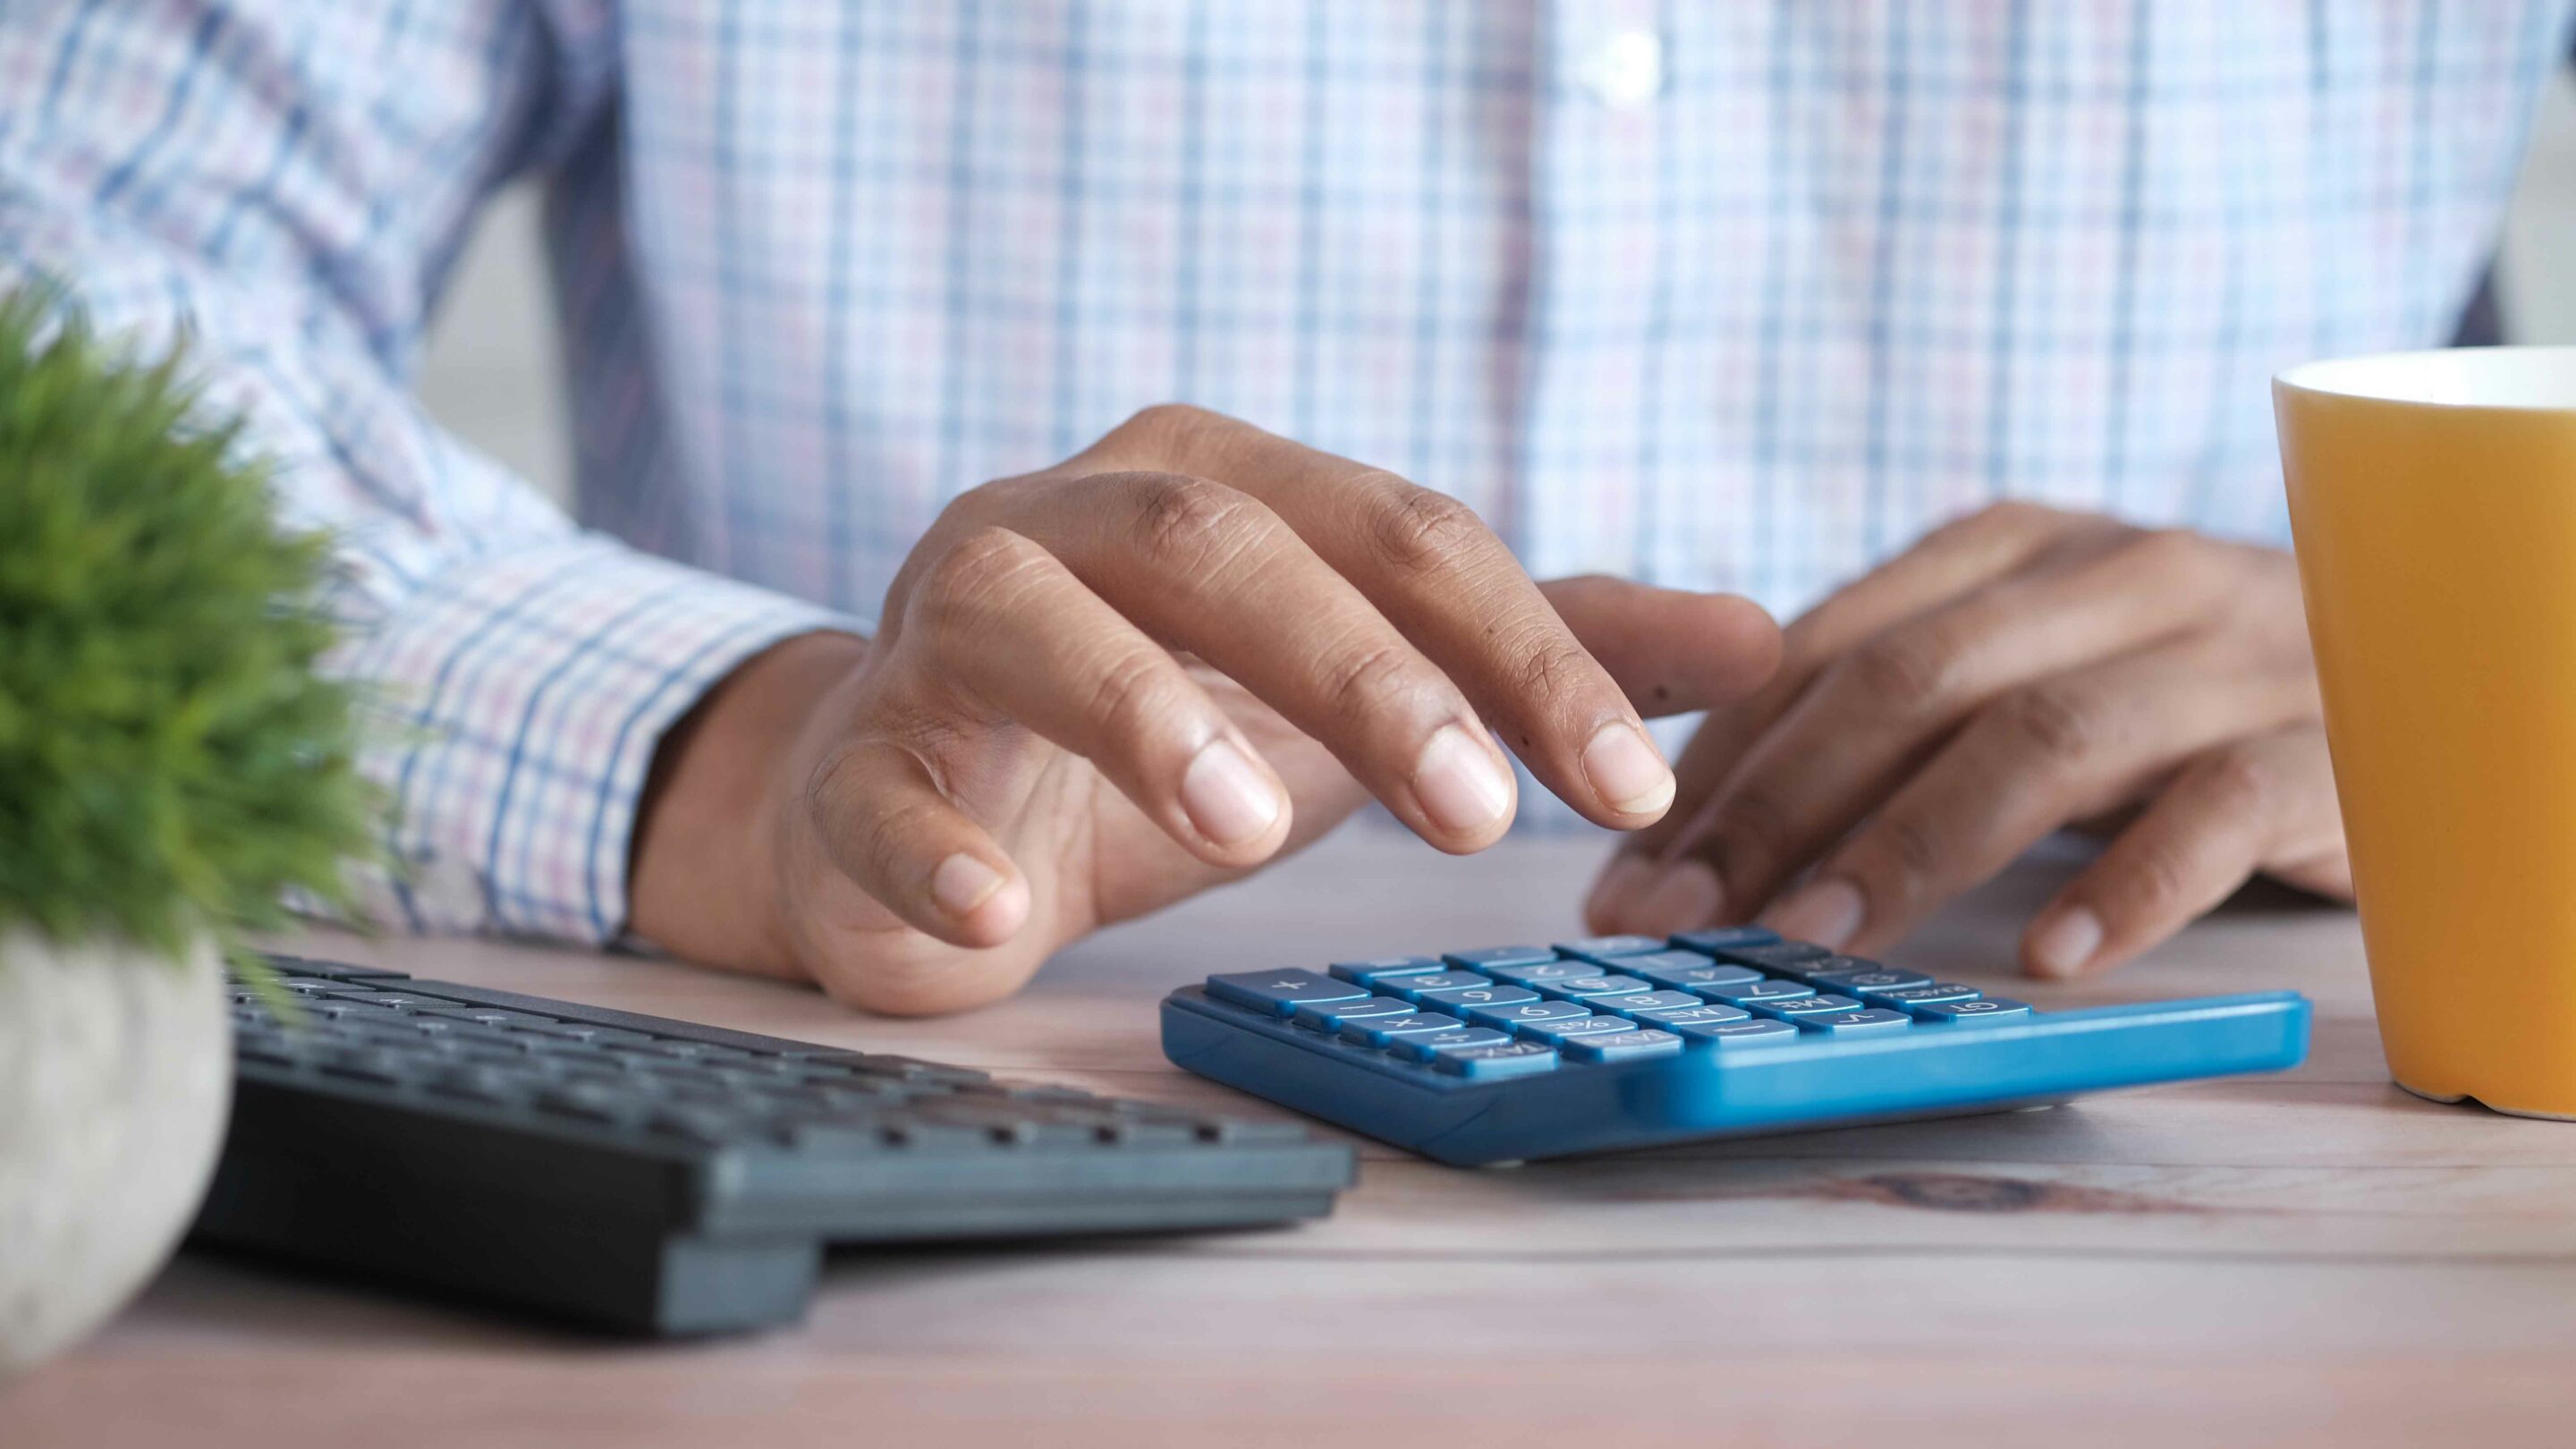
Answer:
(1589, 503, 2351, 977)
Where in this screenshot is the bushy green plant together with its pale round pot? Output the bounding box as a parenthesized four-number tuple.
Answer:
(0, 294, 374, 1372)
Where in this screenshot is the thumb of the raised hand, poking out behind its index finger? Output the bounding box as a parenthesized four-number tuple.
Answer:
(1538, 572, 1780, 719)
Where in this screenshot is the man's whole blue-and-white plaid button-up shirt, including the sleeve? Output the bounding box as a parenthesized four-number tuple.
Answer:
(0, 0, 2576, 938)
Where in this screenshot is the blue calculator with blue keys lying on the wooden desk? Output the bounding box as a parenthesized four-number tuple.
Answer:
(1162, 926, 2308, 1165)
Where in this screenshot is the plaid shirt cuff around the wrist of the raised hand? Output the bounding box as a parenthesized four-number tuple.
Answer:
(333, 534, 869, 944)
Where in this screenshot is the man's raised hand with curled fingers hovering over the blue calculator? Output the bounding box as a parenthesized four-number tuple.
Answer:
(633, 407, 1780, 1013)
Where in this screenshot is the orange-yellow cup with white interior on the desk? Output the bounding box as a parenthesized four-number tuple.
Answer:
(2272, 348, 2576, 1119)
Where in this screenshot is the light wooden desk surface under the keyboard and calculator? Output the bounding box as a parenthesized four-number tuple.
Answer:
(0, 835, 2576, 1449)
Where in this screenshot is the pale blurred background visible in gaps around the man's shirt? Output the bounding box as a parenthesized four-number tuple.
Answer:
(419, 72, 2576, 497)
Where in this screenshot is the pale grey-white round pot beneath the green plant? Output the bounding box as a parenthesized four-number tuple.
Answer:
(0, 928, 232, 1377)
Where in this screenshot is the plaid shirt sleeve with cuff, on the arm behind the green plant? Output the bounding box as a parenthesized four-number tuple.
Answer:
(0, 0, 858, 941)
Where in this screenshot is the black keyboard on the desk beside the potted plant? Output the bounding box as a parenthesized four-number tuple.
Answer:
(193, 956, 1352, 1333)
